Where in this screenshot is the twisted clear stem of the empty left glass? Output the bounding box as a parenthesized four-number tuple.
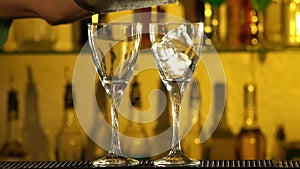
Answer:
(110, 85, 123, 155)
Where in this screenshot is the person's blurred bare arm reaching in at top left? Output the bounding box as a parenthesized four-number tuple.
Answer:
(0, 0, 92, 25)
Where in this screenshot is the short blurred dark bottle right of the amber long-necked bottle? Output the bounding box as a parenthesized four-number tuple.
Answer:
(272, 125, 287, 160)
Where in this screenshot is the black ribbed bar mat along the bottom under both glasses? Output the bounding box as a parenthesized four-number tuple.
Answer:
(0, 160, 300, 169)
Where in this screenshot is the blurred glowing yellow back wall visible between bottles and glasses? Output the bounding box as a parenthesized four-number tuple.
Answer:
(0, 0, 300, 159)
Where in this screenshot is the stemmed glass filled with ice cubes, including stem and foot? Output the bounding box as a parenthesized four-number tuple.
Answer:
(149, 22, 204, 167)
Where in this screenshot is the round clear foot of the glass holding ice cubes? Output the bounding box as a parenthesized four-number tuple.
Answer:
(154, 154, 200, 167)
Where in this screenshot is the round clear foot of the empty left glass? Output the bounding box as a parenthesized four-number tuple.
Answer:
(93, 153, 140, 167)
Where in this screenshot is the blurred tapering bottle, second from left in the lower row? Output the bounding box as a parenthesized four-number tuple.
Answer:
(23, 66, 50, 161)
